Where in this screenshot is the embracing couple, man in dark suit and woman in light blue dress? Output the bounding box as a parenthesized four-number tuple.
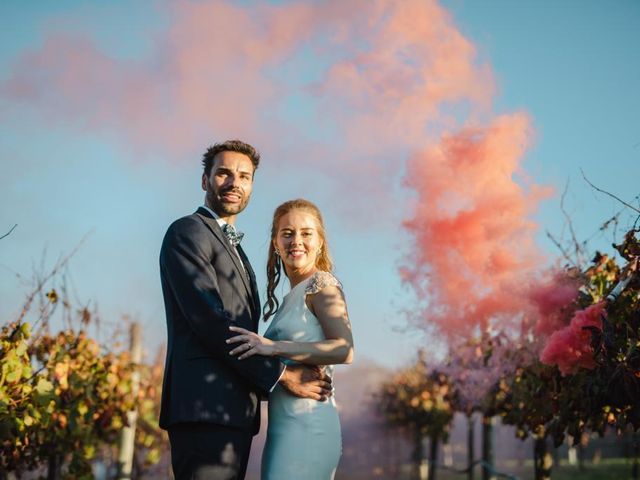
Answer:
(160, 140, 353, 480)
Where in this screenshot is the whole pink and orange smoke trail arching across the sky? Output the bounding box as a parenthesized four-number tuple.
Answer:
(0, 0, 549, 338)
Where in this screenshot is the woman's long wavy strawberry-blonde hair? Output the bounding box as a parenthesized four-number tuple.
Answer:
(262, 198, 333, 321)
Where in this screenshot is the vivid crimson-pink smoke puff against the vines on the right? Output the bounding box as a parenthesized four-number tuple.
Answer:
(540, 302, 606, 375)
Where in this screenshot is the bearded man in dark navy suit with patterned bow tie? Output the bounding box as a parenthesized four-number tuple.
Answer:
(160, 140, 331, 480)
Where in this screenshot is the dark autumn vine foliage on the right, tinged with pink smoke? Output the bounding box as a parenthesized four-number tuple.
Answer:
(381, 230, 640, 478)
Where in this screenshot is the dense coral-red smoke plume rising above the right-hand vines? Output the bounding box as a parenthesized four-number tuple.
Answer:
(403, 114, 551, 335)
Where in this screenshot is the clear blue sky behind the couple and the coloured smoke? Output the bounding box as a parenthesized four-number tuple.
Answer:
(0, 0, 640, 366)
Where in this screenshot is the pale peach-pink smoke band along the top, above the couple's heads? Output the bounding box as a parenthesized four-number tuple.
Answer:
(1, 0, 493, 167)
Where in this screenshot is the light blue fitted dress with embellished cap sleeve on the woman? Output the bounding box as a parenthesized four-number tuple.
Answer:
(262, 272, 342, 480)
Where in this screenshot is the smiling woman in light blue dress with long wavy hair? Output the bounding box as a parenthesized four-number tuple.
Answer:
(229, 199, 353, 480)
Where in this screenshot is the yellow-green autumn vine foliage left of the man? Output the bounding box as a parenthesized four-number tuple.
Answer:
(0, 282, 165, 478)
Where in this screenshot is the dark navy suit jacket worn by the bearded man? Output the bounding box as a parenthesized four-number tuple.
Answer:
(160, 208, 284, 433)
